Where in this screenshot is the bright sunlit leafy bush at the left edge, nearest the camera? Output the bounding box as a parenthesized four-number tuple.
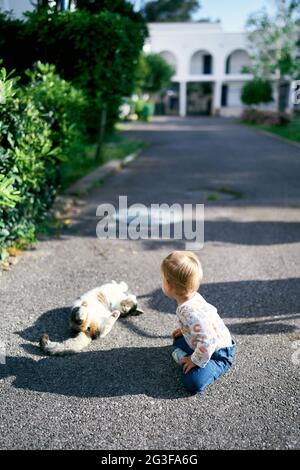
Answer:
(0, 64, 85, 257)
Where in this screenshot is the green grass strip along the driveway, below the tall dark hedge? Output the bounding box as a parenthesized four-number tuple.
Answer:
(61, 132, 145, 190)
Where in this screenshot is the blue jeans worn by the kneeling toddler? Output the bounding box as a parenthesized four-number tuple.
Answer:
(173, 336, 235, 393)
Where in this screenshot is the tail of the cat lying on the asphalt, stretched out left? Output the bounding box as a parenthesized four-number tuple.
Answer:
(40, 332, 92, 356)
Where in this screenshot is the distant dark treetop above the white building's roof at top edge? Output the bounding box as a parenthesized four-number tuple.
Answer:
(141, 0, 200, 23)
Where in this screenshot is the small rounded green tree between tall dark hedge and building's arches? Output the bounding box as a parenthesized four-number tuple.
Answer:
(136, 54, 175, 95)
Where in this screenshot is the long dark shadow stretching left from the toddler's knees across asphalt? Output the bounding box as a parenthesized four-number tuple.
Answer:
(0, 346, 189, 399)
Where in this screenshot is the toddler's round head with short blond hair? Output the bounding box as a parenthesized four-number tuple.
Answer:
(161, 251, 203, 295)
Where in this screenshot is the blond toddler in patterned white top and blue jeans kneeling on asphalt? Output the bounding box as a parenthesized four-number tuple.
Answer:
(161, 251, 235, 393)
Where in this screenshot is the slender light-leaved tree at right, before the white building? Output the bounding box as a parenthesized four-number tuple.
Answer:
(247, 0, 300, 112)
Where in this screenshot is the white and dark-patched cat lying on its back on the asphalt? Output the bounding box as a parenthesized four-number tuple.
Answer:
(40, 281, 143, 355)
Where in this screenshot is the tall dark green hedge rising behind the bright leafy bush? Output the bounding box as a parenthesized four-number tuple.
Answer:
(0, 10, 147, 132)
